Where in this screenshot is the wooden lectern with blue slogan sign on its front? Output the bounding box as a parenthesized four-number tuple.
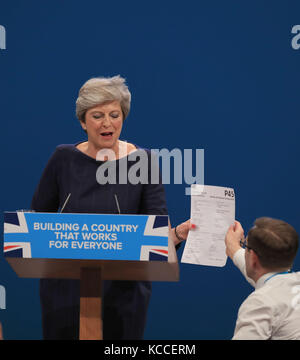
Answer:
(4, 211, 179, 340)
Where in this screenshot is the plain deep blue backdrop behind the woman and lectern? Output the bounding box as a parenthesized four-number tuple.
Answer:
(0, 0, 300, 339)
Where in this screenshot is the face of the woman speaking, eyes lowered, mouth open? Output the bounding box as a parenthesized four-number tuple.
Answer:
(81, 100, 123, 151)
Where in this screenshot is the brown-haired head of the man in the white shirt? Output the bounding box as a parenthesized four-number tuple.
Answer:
(248, 217, 298, 270)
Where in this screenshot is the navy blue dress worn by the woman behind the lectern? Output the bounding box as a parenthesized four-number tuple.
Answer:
(31, 144, 167, 340)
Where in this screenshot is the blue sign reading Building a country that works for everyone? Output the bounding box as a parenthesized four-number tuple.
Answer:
(4, 212, 168, 261)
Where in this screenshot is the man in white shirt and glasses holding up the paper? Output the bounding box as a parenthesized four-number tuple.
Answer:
(225, 218, 300, 340)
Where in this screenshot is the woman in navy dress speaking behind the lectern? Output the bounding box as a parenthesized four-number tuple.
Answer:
(31, 76, 189, 340)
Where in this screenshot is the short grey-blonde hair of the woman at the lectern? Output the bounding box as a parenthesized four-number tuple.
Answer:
(76, 75, 131, 122)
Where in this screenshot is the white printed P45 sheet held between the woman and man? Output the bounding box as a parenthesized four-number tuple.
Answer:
(181, 184, 235, 266)
